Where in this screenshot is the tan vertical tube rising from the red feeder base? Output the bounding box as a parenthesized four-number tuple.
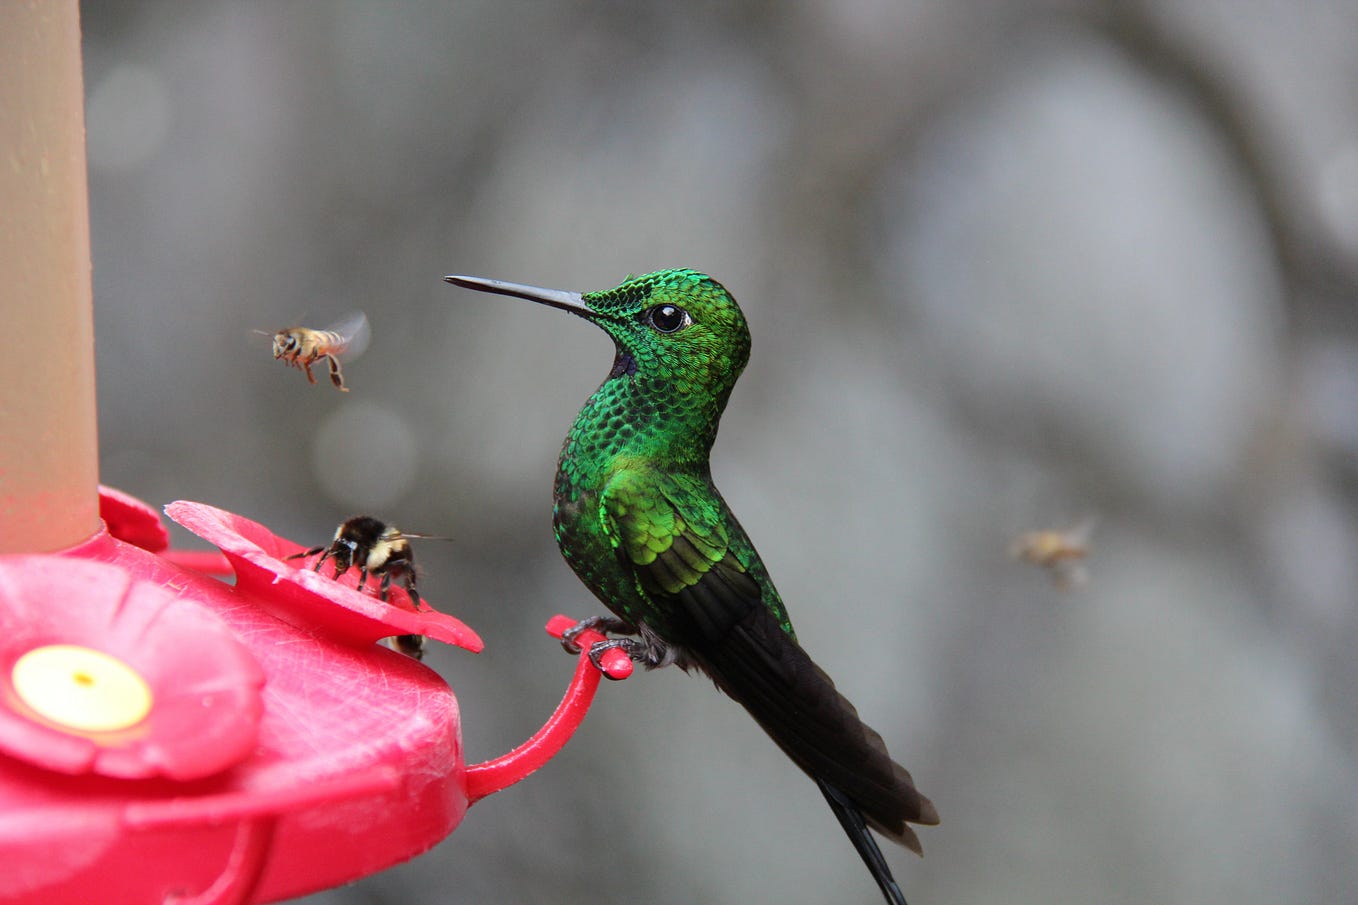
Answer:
(0, 0, 99, 553)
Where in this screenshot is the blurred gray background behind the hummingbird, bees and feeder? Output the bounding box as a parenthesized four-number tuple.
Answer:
(83, 0, 1358, 905)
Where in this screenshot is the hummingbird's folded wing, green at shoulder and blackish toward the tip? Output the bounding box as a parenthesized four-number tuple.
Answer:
(600, 469, 938, 858)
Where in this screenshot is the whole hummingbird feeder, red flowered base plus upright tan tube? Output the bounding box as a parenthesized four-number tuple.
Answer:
(0, 1, 631, 905)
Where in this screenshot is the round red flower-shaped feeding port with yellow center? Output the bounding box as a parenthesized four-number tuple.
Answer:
(0, 556, 263, 780)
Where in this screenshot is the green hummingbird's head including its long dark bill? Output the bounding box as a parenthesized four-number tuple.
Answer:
(444, 270, 750, 395)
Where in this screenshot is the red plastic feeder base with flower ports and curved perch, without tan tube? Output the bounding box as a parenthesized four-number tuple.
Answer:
(0, 491, 631, 905)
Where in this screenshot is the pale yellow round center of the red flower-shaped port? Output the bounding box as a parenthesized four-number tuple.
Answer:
(10, 644, 151, 732)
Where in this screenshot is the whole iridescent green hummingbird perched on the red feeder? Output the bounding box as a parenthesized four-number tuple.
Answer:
(444, 264, 938, 905)
